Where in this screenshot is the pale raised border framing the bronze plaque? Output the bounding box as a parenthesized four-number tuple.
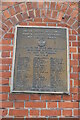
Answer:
(9, 25, 70, 95)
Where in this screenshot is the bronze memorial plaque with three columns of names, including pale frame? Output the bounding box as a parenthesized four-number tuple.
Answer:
(12, 26, 69, 93)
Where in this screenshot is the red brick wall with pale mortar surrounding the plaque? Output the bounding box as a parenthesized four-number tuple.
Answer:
(0, 2, 80, 118)
